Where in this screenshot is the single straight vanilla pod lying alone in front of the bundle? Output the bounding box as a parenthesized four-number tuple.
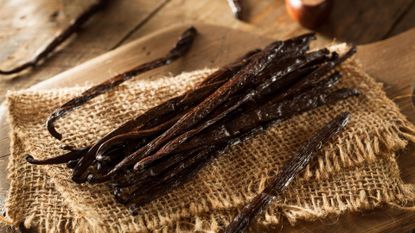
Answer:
(224, 112, 350, 233)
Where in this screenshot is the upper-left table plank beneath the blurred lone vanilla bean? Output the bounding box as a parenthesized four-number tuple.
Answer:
(0, 0, 168, 101)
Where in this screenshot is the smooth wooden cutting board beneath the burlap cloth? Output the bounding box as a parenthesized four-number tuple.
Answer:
(0, 25, 415, 233)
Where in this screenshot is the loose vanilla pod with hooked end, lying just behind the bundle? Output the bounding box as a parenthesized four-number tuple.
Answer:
(46, 27, 197, 140)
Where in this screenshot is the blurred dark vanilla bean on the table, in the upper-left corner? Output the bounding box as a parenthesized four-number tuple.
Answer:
(0, 0, 108, 75)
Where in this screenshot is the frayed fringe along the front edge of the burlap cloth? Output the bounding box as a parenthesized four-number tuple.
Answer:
(147, 158, 415, 233)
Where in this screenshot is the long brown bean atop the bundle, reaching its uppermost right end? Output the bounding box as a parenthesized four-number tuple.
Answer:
(90, 34, 315, 182)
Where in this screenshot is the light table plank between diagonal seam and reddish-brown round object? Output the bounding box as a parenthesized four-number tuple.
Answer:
(122, 0, 308, 41)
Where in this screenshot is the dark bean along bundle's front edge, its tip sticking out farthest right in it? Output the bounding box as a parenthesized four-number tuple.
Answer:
(112, 85, 359, 198)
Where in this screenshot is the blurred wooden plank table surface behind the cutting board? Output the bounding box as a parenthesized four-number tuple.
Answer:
(0, 0, 415, 231)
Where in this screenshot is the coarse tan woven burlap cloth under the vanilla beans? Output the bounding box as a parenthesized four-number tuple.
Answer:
(6, 57, 415, 232)
